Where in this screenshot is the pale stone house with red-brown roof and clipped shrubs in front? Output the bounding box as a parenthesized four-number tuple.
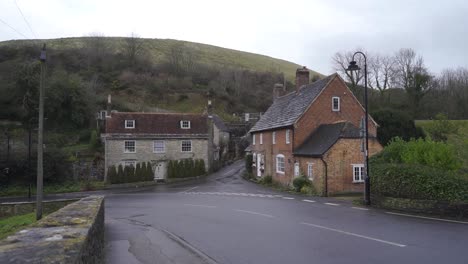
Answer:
(101, 112, 212, 182)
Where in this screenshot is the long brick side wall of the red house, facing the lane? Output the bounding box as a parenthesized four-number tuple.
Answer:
(252, 129, 294, 184)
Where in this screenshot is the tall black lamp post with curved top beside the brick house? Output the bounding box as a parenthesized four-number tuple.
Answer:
(347, 51, 370, 205)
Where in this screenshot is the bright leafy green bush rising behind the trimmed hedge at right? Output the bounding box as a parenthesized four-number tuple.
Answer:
(371, 138, 462, 171)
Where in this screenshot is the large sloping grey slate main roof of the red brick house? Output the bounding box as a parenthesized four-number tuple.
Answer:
(250, 74, 336, 132)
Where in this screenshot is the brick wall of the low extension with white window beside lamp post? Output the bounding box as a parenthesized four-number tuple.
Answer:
(322, 138, 383, 195)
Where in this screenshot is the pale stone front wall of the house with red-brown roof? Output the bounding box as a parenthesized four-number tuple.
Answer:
(105, 139, 209, 177)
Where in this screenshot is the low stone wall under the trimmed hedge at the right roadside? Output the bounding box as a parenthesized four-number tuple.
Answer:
(372, 196, 468, 219)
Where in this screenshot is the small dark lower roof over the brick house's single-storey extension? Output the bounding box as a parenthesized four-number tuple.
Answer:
(294, 122, 360, 157)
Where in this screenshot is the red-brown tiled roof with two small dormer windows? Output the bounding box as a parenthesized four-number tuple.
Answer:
(106, 112, 208, 135)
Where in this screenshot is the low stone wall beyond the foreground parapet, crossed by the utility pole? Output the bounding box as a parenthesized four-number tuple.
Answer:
(0, 199, 79, 218)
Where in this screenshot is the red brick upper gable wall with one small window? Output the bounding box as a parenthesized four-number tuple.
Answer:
(294, 77, 377, 147)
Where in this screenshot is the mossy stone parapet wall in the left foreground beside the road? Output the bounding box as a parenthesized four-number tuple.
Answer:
(0, 196, 104, 264)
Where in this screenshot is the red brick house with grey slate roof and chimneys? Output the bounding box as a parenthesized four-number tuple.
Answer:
(250, 67, 382, 196)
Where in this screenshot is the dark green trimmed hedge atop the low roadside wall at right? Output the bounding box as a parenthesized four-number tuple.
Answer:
(370, 163, 468, 201)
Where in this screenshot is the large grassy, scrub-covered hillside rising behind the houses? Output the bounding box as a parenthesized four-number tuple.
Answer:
(0, 36, 320, 127)
